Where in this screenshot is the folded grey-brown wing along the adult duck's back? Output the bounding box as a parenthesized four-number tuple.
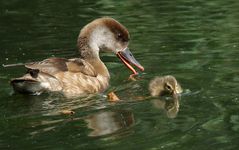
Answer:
(25, 58, 97, 77)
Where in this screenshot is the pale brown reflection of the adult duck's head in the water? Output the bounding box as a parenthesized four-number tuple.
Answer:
(85, 110, 135, 136)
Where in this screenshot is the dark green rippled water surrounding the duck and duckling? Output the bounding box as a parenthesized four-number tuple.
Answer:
(0, 0, 239, 150)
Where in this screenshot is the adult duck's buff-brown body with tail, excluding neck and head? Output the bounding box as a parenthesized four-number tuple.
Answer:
(11, 58, 110, 97)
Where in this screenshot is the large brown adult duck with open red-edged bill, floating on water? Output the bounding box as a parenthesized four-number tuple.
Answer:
(11, 17, 144, 97)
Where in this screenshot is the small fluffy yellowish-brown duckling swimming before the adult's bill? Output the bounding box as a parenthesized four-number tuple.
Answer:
(149, 75, 182, 96)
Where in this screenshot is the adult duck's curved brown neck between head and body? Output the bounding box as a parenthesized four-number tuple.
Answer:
(77, 36, 110, 78)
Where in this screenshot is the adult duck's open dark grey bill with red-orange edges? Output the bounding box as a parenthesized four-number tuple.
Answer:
(117, 48, 144, 74)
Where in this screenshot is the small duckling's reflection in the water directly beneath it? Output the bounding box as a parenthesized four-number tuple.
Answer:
(152, 96, 180, 118)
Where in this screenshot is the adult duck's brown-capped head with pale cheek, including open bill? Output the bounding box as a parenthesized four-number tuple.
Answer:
(78, 17, 144, 74)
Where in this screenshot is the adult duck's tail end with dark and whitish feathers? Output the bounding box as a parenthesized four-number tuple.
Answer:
(10, 69, 62, 95)
